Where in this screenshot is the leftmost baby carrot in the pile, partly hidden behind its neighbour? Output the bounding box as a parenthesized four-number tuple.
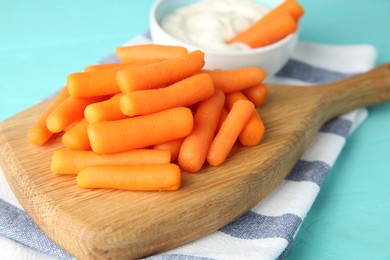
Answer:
(27, 87, 69, 145)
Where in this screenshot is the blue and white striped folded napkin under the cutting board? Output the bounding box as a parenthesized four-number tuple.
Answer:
(0, 34, 376, 260)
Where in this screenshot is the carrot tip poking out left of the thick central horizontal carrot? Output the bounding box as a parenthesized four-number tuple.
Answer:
(62, 118, 91, 150)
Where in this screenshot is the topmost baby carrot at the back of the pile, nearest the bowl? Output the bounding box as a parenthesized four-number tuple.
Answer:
(116, 44, 188, 63)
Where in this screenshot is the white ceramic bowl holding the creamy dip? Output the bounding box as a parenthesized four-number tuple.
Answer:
(150, 0, 298, 75)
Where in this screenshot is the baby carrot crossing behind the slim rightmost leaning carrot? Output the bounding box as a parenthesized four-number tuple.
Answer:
(225, 92, 265, 146)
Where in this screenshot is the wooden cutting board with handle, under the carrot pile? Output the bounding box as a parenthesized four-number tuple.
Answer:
(0, 64, 390, 259)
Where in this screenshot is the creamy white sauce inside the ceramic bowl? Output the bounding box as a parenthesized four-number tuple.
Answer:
(161, 0, 269, 51)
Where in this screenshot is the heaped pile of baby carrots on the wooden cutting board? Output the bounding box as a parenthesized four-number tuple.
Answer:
(28, 44, 267, 191)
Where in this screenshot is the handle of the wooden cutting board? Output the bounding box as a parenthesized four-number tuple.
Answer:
(313, 63, 390, 119)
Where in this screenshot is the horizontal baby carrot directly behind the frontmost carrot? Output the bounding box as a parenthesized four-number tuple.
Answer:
(50, 149, 171, 174)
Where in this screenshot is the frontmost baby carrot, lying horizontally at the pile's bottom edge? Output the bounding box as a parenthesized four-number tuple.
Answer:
(76, 163, 181, 191)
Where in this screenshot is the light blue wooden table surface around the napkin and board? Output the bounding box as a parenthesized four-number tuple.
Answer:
(0, 0, 390, 259)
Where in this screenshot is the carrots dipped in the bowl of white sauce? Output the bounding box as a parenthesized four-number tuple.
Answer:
(227, 0, 305, 48)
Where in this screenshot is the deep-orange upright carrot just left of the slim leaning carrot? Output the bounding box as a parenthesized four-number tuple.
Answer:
(178, 90, 225, 173)
